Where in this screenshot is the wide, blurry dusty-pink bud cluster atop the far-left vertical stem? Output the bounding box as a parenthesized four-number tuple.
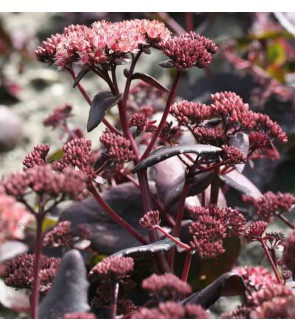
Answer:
(3, 165, 86, 200)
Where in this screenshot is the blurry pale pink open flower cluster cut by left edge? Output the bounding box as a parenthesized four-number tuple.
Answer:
(0, 186, 34, 244)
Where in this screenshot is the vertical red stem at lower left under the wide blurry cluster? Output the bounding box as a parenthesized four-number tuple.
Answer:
(31, 213, 43, 319)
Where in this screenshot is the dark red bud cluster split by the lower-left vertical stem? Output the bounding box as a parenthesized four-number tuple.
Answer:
(4, 254, 61, 294)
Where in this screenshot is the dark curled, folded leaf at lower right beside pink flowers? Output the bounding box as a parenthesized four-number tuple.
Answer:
(182, 272, 246, 309)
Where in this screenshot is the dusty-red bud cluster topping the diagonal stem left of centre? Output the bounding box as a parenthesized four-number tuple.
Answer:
(56, 138, 96, 181)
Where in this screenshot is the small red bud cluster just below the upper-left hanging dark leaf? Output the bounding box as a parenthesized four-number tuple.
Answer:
(100, 130, 135, 164)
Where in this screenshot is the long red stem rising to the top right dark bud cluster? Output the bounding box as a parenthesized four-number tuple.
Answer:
(140, 71, 182, 160)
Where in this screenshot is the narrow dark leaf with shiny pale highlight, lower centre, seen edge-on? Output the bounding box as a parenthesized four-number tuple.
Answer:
(112, 238, 176, 257)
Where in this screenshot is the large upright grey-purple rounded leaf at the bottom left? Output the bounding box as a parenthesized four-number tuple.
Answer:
(38, 249, 90, 319)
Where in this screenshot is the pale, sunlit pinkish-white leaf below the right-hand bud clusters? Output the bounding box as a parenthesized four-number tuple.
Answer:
(219, 170, 262, 198)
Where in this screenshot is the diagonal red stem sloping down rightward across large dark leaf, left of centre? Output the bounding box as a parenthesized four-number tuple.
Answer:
(88, 183, 148, 244)
